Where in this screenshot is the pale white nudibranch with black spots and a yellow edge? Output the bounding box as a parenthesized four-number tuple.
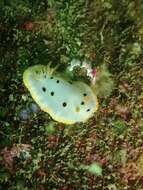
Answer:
(23, 65, 98, 124)
